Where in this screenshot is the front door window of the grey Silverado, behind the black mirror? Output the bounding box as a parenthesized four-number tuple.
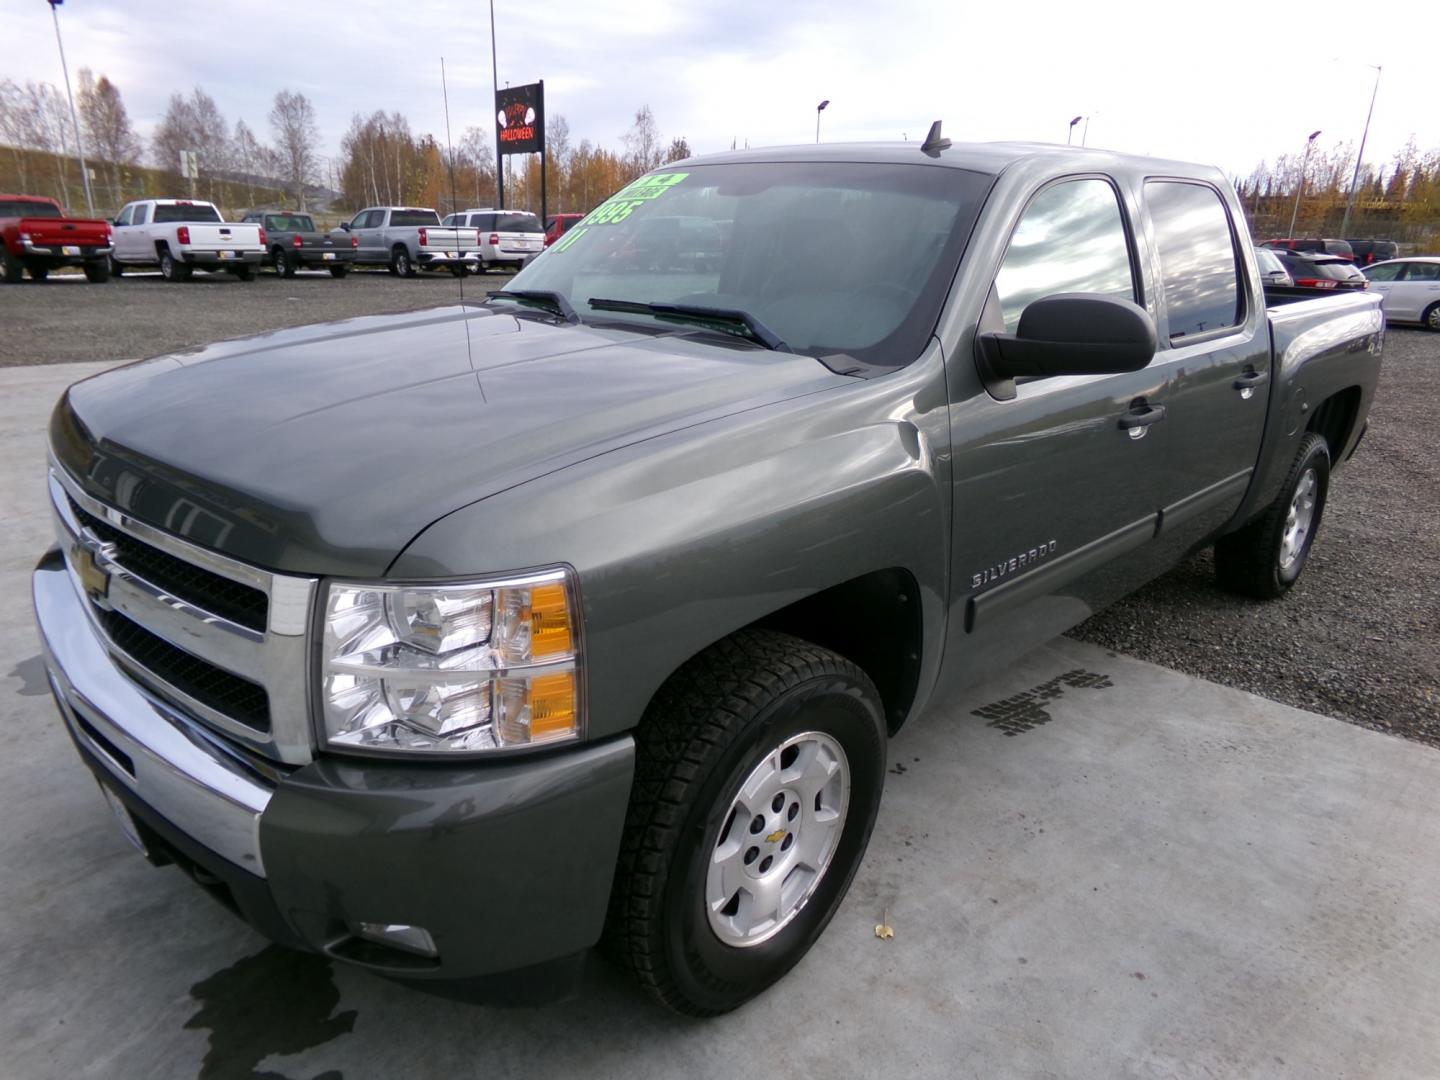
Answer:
(995, 177, 1135, 334)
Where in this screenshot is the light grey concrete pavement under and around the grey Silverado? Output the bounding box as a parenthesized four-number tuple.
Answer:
(0, 364, 1440, 1080)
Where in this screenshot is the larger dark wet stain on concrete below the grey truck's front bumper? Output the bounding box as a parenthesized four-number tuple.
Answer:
(184, 945, 359, 1080)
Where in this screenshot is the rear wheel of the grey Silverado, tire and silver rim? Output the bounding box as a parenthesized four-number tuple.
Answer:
(1215, 432, 1331, 600)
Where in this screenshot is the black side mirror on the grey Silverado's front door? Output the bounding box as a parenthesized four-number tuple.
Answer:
(979, 292, 1155, 380)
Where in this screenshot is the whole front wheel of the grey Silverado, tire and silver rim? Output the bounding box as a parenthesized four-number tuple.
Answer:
(605, 631, 886, 1017)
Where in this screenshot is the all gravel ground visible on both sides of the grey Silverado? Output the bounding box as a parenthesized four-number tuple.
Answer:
(0, 271, 1440, 746)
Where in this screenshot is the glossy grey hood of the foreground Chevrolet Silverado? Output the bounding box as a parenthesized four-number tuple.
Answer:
(50, 308, 852, 576)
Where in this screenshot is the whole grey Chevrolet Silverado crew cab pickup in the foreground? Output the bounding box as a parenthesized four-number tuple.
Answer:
(33, 137, 1384, 1015)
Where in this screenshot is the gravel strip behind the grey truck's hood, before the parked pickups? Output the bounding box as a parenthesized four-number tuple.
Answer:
(0, 269, 511, 367)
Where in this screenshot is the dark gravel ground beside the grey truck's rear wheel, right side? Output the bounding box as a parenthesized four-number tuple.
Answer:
(1071, 328, 1440, 746)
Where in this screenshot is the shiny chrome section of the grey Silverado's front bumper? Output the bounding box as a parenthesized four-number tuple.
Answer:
(30, 550, 275, 877)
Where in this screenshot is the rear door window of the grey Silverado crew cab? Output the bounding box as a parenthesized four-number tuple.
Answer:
(1145, 180, 1244, 341)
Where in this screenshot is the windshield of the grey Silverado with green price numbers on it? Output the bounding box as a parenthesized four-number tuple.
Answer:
(513, 161, 992, 366)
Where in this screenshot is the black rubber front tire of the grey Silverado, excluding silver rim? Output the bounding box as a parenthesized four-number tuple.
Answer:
(603, 631, 886, 1017)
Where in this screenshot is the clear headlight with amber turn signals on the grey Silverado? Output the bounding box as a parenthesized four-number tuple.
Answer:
(320, 570, 580, 752)
